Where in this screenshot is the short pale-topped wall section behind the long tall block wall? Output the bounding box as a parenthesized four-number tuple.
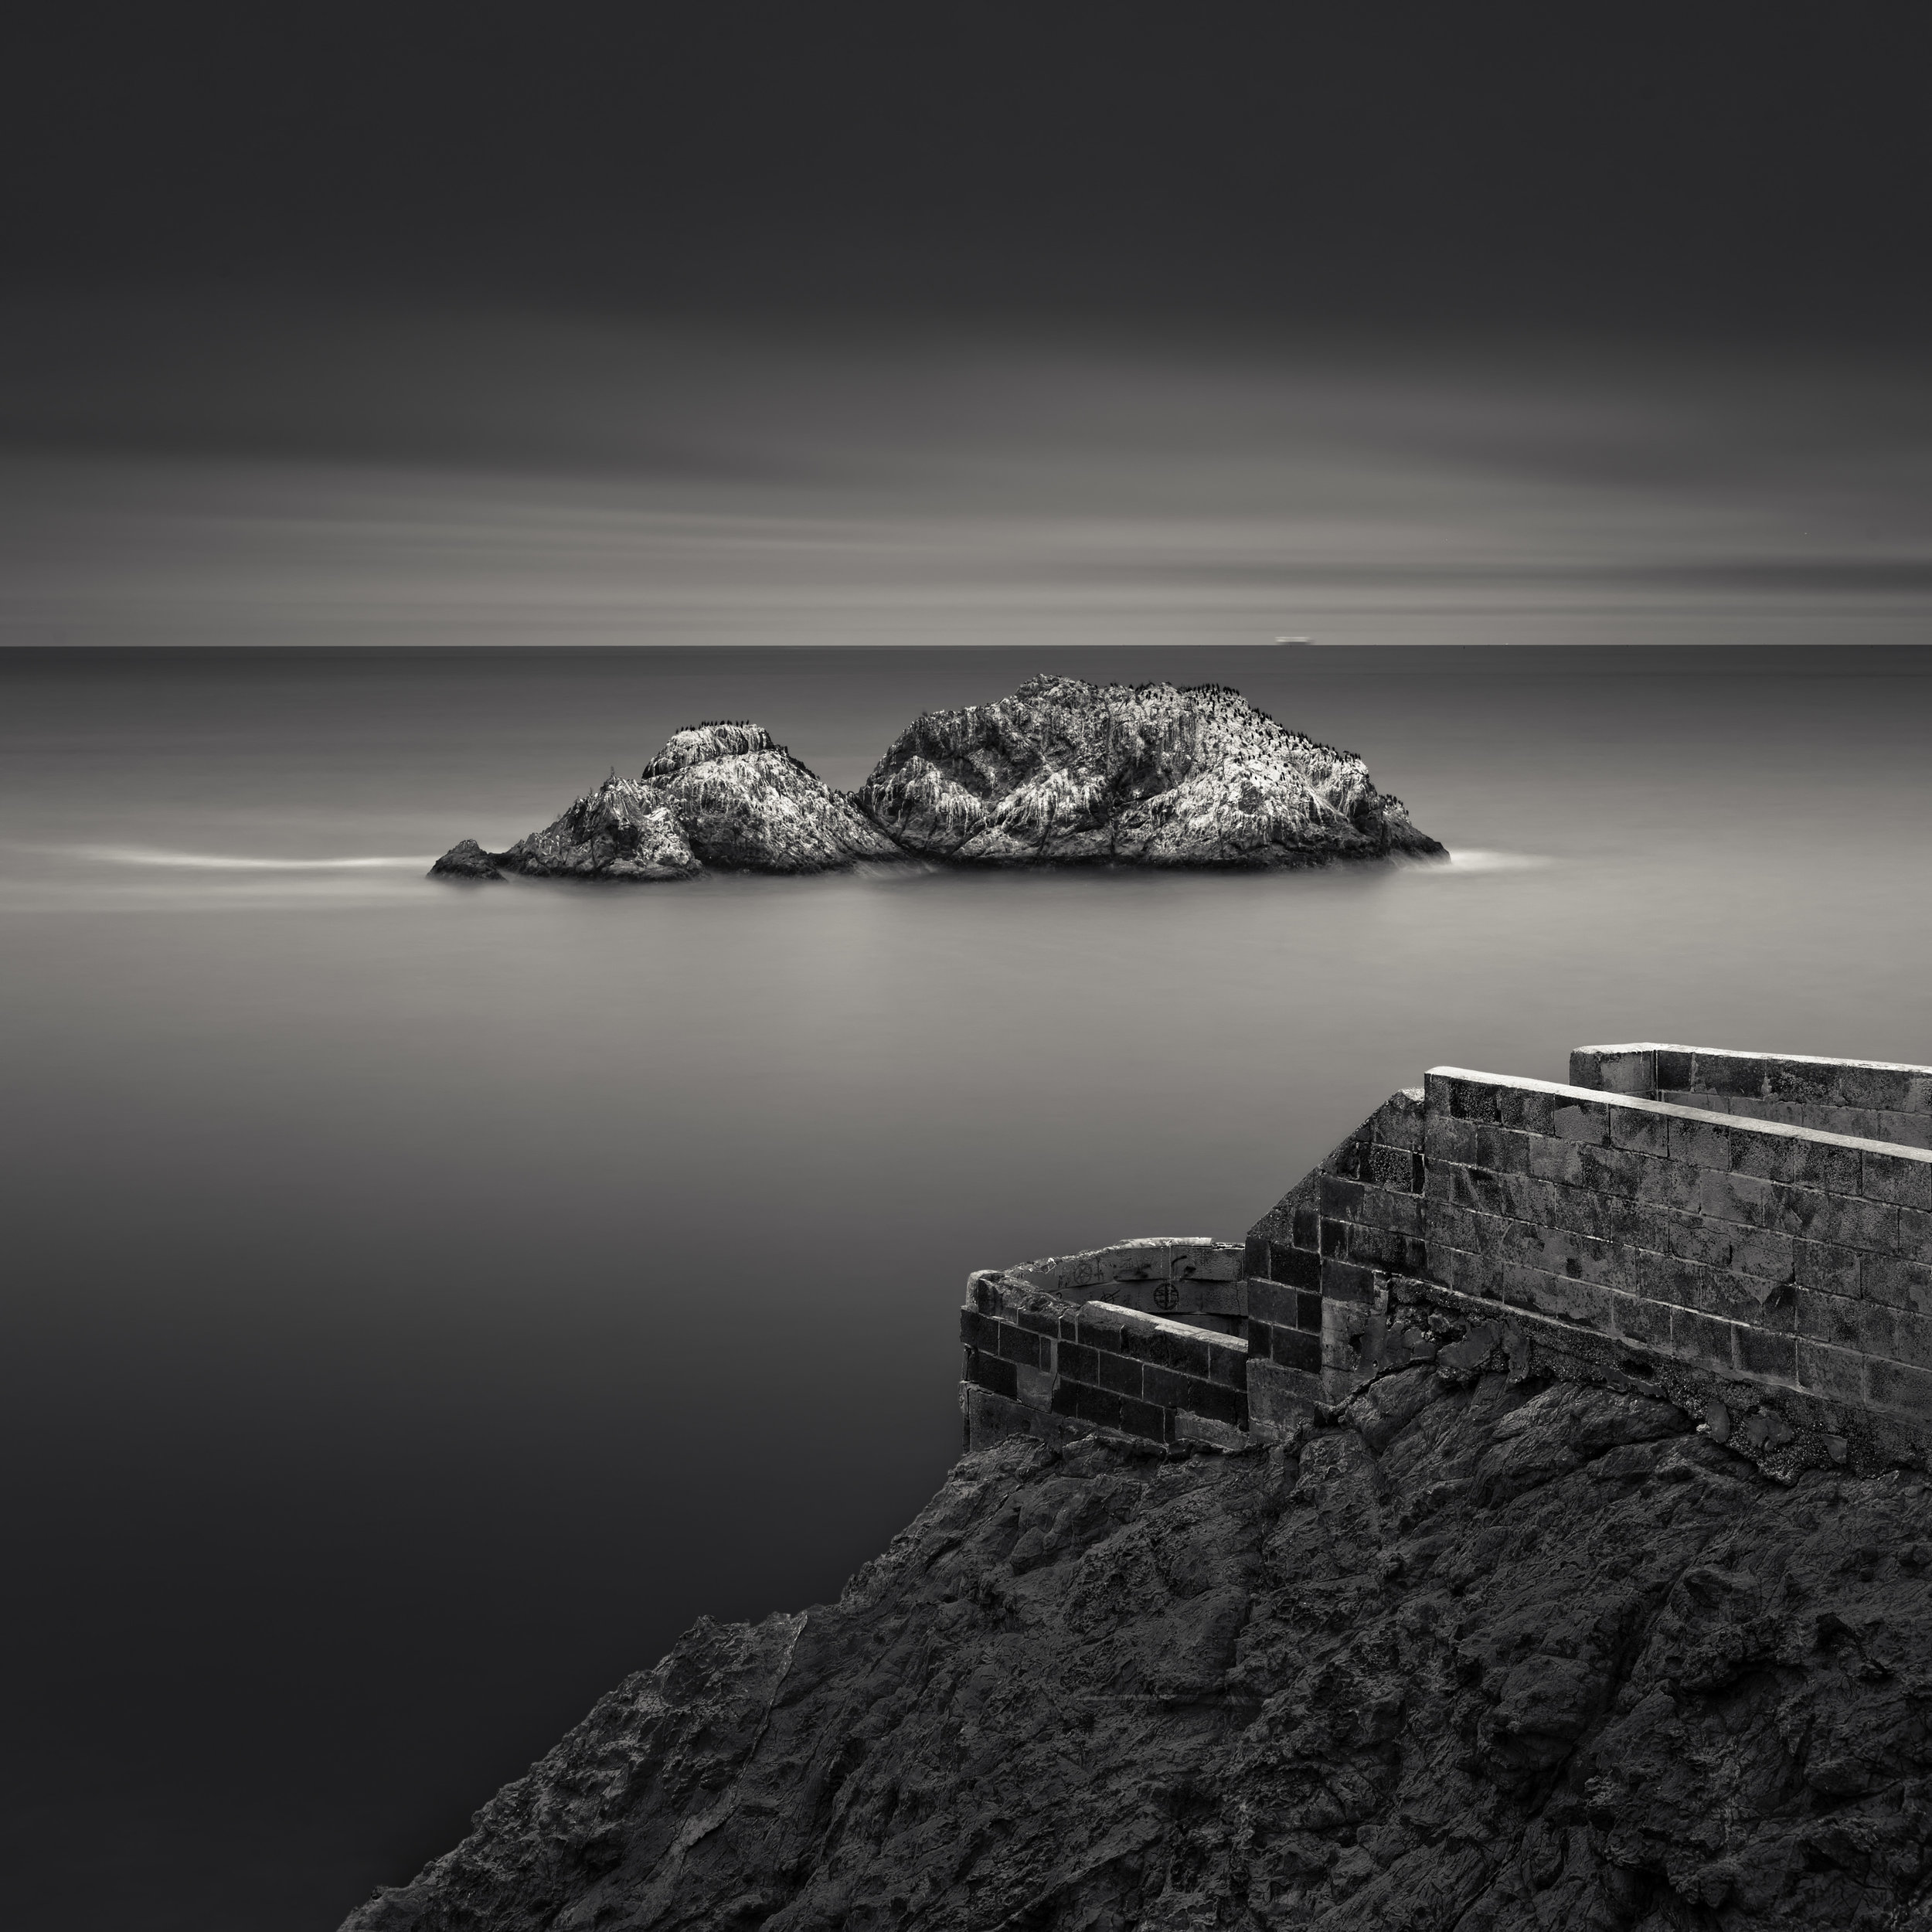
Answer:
(1571, 1042, 1932, 1148)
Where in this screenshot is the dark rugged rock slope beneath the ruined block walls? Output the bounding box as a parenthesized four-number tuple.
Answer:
(346, 1366, 1932, 1932)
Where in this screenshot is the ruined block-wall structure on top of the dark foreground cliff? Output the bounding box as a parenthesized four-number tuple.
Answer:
(962, 1046, 1932, 1475)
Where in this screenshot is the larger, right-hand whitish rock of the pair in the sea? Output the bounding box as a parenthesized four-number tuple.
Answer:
(858, 679, 1444, 866)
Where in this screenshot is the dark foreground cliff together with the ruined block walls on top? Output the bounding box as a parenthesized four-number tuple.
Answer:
(344, 1043, 1932, 1932)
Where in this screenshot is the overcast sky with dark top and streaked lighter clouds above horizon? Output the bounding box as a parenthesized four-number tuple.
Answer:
(0, 0, 1932, 641)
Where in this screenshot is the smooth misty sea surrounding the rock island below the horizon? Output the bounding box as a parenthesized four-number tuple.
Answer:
(0, 648, 1932, 1932)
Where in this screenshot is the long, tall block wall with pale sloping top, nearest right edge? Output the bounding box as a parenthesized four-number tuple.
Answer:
(1424, 1069, 1932, 1432)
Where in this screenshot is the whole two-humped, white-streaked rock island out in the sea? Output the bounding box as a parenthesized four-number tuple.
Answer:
(431, 676, 1444, 881)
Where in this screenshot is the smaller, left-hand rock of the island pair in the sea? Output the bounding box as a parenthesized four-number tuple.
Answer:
(431, 721, 900, 879)
